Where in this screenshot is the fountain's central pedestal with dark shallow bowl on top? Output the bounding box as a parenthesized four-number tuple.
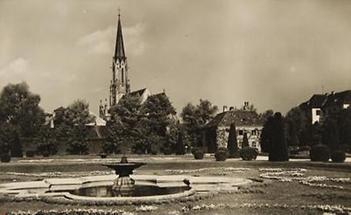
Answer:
(104, 156, 146, 196)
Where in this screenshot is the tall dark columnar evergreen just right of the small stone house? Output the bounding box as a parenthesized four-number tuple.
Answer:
(269, 112, 289, 161)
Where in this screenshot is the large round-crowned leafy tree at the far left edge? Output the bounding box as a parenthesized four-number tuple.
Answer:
(0, 82, 45, 156)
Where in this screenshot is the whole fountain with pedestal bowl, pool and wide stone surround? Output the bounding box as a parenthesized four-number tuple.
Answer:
(0, 156, 250, 205)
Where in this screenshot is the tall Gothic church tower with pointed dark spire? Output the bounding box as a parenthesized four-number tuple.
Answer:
(110, 14, 130, 106)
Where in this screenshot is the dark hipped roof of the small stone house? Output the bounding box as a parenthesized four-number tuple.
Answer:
(206, 110, 263, 127)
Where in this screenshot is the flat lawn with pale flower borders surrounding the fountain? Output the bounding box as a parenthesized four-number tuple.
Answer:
(0, 155, 351, 215)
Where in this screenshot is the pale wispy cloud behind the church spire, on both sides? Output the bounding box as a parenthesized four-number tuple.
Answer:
(77, 23, 145, 56)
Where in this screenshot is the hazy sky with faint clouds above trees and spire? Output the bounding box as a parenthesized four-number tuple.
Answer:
(0, 0, 351, 112)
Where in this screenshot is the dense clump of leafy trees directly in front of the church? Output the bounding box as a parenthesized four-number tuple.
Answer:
(104, 93, 177, 154)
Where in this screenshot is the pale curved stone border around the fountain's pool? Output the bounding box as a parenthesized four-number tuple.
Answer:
(0, 175, 251, 205)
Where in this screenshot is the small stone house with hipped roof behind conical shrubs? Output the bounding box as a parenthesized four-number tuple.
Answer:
(204, 102, 263, 152)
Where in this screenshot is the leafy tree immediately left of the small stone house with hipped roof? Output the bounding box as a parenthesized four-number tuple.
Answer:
(180, 99, 218, 147)
